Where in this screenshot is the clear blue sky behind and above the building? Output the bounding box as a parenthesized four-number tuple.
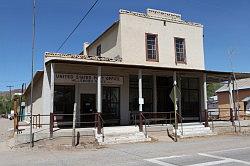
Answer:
(0, 0, 250, 91)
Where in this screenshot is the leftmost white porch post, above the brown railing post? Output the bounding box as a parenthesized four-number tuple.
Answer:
(50, 63, 55, 113)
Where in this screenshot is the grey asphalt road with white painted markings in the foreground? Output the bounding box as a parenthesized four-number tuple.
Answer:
(0, 136, 250, 166)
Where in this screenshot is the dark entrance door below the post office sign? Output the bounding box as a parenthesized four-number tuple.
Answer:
(80, 94, 96, 127)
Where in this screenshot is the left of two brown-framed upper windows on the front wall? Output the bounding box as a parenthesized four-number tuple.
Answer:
(146, 33, 158, 61)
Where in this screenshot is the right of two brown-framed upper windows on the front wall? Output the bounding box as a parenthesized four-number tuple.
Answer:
(175, 38, 186, 63)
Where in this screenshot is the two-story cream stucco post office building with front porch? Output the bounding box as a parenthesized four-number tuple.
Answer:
(23, 9, 248, 130)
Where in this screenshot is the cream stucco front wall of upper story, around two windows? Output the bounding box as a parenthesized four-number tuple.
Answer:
(120, 14, 205, 69)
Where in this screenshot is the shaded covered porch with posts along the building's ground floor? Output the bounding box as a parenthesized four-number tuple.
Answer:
(46, 59, 216, 134)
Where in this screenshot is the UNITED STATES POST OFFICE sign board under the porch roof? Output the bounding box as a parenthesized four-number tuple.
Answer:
(55, 73, 123, 85)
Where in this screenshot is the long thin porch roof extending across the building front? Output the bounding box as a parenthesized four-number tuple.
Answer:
(45, 57, 250, 82)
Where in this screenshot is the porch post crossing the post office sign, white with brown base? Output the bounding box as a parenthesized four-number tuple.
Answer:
(97, 66, 102, 134)
